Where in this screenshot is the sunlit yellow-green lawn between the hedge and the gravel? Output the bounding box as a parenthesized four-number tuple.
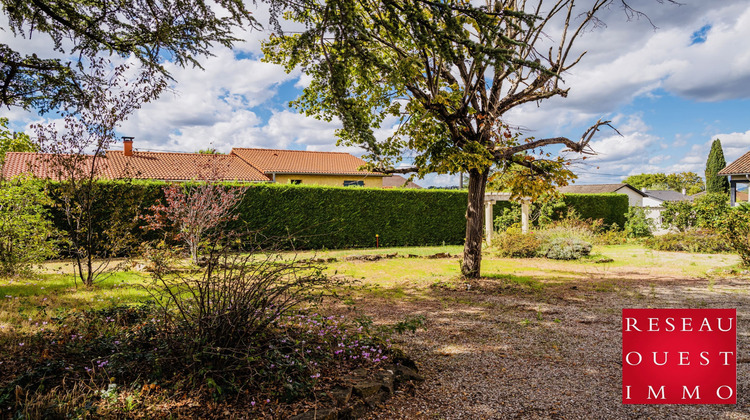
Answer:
(0, 244, 739, 332)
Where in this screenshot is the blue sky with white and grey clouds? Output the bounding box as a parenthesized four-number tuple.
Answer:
(0, 0, 750, 186)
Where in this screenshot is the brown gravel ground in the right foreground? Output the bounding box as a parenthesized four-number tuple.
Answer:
(358, 279, 750, 419)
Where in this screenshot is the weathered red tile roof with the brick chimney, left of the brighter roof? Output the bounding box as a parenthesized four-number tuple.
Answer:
(3, 150, 270, 182)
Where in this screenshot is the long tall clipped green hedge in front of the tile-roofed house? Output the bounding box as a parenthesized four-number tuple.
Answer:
(45, 181, 467, 249)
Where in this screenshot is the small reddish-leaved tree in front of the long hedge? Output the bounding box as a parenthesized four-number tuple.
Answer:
(143, 172, 244, 264)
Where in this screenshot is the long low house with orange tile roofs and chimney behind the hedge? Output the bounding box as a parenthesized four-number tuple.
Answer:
(2, 139, 386, 188)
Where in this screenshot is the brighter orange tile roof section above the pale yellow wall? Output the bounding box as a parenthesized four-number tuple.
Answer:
(232, 148, 386, 176)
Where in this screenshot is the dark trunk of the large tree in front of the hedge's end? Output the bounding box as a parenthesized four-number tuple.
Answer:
(461, 168, 490, 278)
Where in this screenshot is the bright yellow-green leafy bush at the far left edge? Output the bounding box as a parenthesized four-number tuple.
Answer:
(0, 177, 56, 274)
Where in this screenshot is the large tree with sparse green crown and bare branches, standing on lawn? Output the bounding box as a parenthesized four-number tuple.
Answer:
(264, 0, 632, 277)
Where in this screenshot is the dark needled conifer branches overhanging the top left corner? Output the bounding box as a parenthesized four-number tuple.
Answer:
(0, 0, 255, 113)
